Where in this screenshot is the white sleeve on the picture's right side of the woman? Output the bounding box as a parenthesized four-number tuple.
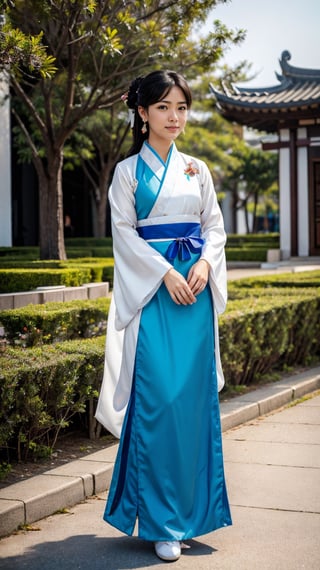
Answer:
(199, 161, 227, 313)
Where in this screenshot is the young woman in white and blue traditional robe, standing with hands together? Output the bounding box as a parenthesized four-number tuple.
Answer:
(96, 71, 231, 560)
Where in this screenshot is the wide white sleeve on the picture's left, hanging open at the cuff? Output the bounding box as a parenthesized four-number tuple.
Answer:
(109, 160, 171, 330)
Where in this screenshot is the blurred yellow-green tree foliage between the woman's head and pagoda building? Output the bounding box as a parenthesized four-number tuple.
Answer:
(175, 70, 278, 233)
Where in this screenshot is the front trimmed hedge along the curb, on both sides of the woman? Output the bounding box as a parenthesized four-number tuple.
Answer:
(0, 287, 320, 459)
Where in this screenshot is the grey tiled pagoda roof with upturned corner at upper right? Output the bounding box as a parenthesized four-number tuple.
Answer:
(210, 51, 320, 132)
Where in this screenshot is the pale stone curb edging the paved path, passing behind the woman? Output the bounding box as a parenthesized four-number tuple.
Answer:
(0, 367, 320, 537)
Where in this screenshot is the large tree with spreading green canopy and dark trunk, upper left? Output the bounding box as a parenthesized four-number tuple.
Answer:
(0, 0, 243, 259)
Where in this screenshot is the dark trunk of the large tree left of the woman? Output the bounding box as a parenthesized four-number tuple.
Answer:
(37, 150, 66, 259)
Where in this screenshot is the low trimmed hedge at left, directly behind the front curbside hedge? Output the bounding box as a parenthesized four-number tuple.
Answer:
(0, 297, 110, 347)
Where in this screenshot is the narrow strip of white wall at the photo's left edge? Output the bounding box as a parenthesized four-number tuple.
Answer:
(0, 74, 12, 246)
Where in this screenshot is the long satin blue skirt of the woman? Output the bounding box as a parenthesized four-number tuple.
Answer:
(104, 242, 232, 541)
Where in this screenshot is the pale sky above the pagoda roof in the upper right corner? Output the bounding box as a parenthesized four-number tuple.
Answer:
(205, 0, 320, 87)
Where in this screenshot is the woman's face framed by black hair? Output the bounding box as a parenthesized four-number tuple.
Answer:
(138, 86, 188, 146)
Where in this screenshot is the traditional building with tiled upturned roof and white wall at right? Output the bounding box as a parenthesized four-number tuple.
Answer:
(212, 51, 320, 259)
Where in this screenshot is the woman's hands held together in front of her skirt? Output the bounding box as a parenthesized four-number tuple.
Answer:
(163, 259, 209, 305)
